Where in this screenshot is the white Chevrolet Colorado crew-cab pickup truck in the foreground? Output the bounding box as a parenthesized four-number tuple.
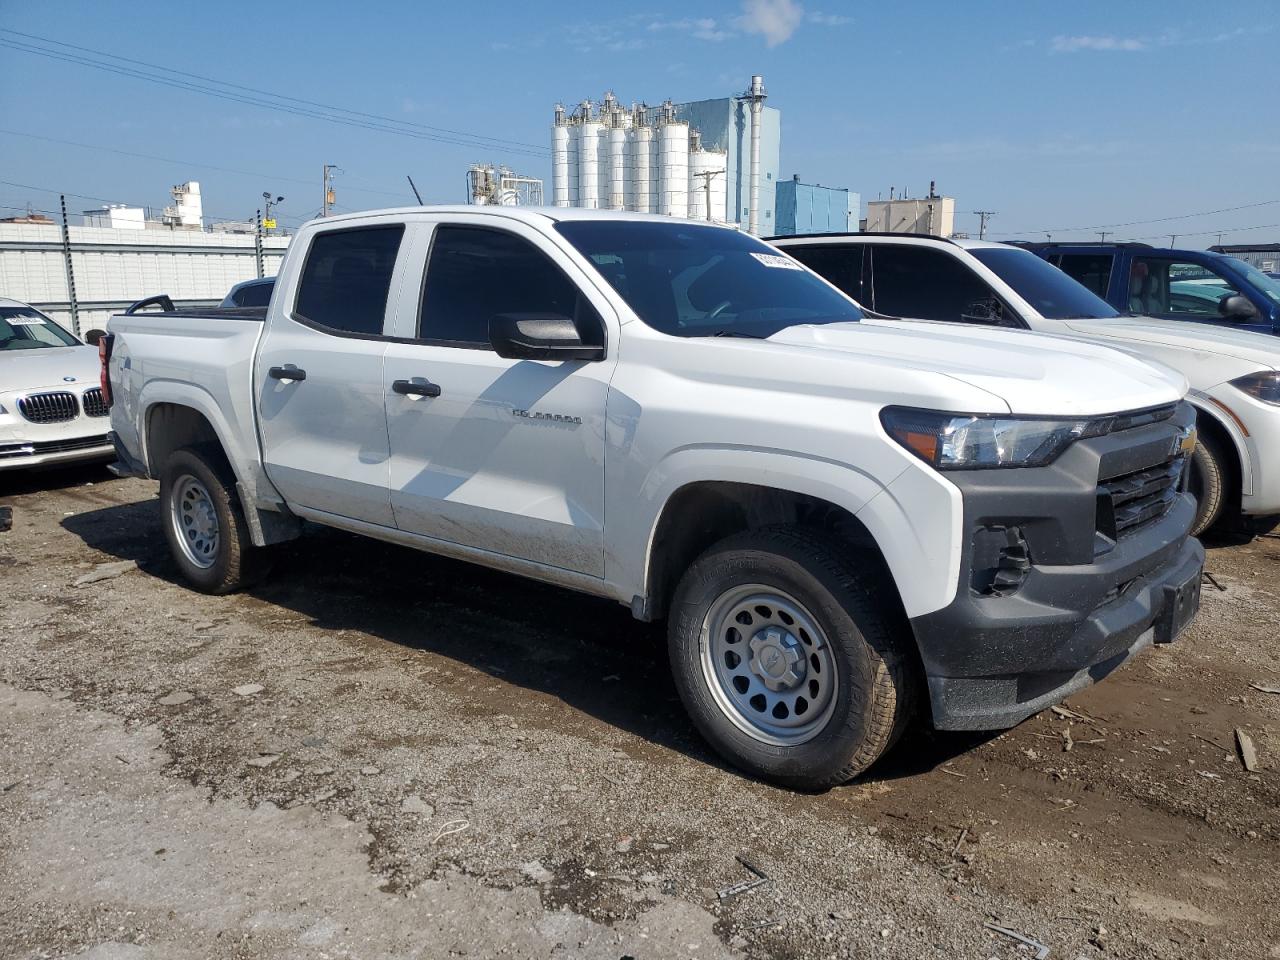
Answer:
(101, 207, 1203, 788)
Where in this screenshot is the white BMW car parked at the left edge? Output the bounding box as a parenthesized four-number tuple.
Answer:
(0, 297, 115, 470)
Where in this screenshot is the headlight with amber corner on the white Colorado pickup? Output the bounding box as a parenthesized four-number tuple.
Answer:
(881, 407, 1111, 470)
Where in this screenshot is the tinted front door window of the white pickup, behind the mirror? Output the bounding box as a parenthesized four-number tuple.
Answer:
(417, 227, 604, 348)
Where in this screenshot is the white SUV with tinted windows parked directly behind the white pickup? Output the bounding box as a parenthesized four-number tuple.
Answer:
(773, 233, 1280, 535)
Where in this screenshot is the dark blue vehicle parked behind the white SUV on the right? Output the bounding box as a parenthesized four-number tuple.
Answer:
(1018, 243, 1280, 334)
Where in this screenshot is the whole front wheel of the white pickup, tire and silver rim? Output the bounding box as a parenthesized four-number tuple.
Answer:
(669, 527, 913, 790)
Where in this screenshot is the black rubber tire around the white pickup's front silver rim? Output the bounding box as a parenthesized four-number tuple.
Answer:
(669, 527, 915, 790)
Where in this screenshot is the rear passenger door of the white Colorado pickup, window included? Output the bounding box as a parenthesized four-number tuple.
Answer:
(253, 221, 407, 526)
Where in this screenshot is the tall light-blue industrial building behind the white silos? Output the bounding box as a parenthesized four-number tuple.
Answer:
(660, 97, 782, 234)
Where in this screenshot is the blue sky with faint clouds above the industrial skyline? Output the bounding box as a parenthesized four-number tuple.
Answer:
(0, 0, 1280, 247)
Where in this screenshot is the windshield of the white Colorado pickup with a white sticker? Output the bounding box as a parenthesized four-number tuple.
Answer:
(556, 220, 861, 337)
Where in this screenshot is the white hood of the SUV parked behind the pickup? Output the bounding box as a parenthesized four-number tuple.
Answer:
(1064, 316, 1280, 378)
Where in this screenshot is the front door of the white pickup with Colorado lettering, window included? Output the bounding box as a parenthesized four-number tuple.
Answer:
(384, 221, 616, 576)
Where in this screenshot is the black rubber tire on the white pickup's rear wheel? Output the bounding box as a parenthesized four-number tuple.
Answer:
(160, 447, 270, 594)
